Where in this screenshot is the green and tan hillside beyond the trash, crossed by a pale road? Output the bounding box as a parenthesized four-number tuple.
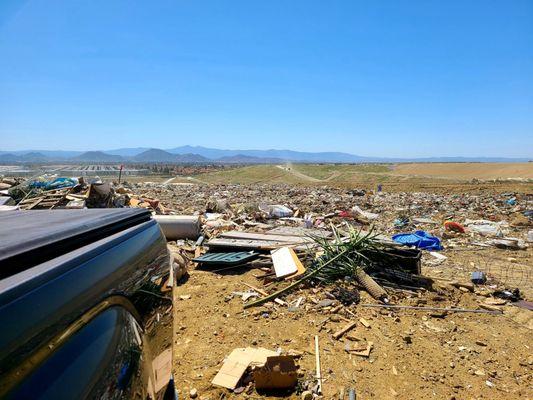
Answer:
(185, 163, 533, 192)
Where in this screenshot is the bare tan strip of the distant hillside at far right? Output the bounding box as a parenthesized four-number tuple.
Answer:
(394, 163, 533, 179)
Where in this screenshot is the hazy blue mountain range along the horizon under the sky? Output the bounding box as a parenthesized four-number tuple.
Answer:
(0, 146, 530, 164)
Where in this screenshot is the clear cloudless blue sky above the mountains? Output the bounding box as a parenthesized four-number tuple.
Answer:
(0, 0, 533, 157)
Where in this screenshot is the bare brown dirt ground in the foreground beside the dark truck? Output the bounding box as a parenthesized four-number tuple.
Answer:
(174, 255, 533, 399)
